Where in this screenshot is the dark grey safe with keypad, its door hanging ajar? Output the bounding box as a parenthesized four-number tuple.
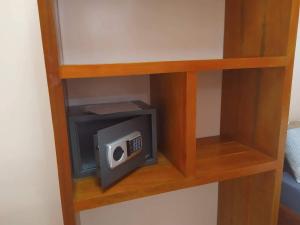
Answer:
(68, 101, 157, 189)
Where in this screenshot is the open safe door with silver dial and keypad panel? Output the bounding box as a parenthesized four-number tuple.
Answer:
(94, 115, 152, 189)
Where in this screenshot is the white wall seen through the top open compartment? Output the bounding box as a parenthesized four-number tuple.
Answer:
(58, 0, 225, 64)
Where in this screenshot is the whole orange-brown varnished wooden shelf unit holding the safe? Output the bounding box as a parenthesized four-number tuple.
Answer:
(38, 0, 299, 225)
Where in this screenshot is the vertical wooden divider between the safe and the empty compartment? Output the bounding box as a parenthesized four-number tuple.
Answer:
(150, 72, 197, 176)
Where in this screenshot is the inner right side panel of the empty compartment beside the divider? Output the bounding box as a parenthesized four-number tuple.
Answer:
(221, 68, 284, 157)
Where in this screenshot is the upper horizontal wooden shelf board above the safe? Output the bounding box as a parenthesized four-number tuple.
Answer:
(59, 56, 288, 79)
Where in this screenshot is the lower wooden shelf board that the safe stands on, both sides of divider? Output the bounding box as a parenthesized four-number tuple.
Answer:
(74, 138, 276, 212)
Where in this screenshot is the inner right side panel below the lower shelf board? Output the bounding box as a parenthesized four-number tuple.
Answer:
(218, 171, 276, 225)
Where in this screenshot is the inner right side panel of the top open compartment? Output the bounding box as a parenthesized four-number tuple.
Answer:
(224, 0, 293, 58)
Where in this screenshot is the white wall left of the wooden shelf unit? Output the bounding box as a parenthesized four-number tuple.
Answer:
(0, 0, 62, 225)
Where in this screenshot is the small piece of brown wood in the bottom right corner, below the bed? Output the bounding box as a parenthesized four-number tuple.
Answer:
(278, 205, 300, 225)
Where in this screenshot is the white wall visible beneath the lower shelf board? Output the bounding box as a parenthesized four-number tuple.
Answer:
(81, 184, 218, 225)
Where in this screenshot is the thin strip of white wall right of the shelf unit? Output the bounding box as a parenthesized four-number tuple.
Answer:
(290, 23, 300, 121)
